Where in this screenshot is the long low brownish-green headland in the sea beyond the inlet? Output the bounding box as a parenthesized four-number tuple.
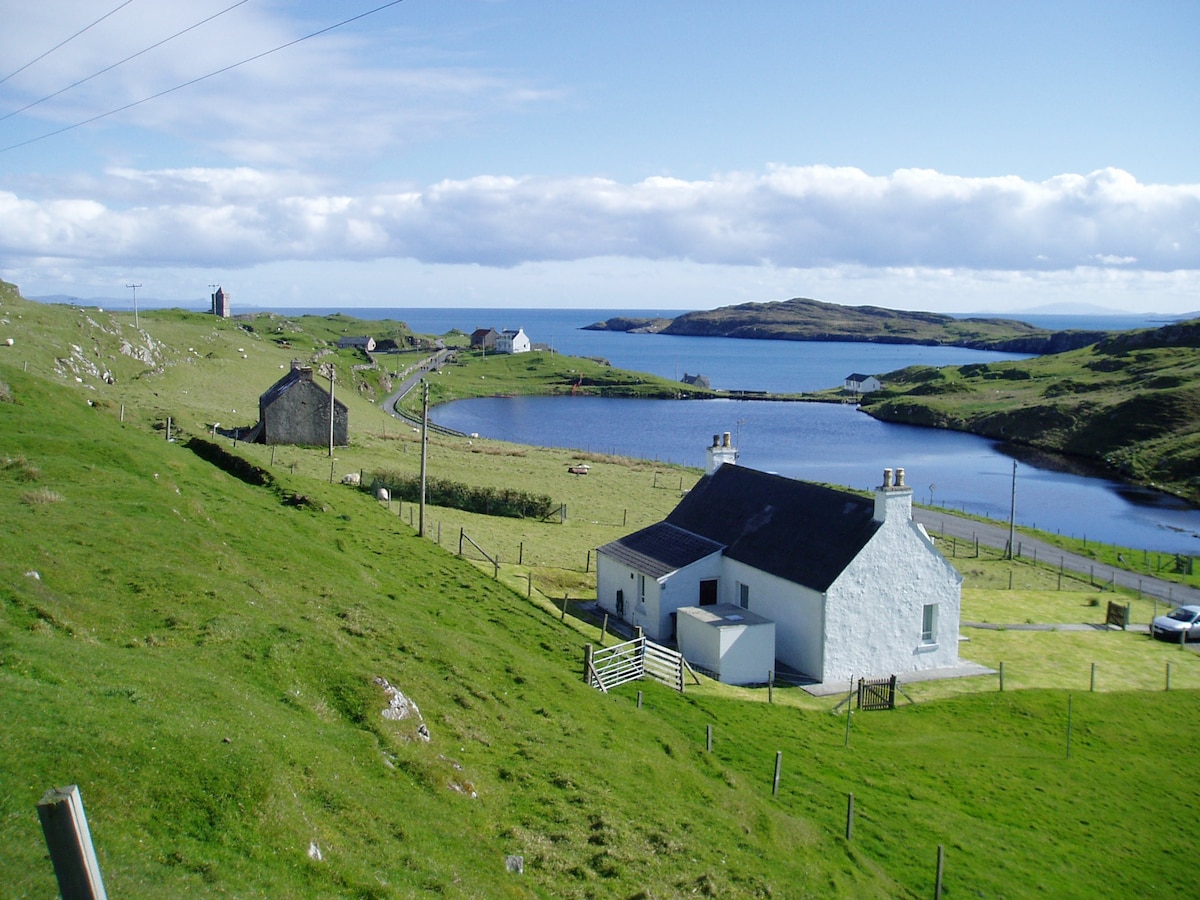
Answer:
(587, 298, 1109, 354)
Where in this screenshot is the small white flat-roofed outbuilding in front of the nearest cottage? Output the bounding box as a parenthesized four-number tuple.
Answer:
(676, 604, 775, 684)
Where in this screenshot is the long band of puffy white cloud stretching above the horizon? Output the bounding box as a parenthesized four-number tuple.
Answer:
(0, 166, 1200, 271)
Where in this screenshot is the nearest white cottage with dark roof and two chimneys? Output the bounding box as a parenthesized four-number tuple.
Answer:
(596, 440, 962, 683)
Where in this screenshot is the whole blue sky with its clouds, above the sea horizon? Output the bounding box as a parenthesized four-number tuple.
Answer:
(0, 0, 1200, 313)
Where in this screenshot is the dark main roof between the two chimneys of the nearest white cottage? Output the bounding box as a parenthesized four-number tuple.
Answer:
(666, 464, 880, 593)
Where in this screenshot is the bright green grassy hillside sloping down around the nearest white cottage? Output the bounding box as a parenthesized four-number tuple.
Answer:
(0, 287, 1200, 898)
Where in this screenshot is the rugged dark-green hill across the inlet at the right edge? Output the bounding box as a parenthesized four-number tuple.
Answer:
(863, 320, 1200, 504)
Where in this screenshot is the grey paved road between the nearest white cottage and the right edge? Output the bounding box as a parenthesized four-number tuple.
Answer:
(912, 506, 1200, 606)
